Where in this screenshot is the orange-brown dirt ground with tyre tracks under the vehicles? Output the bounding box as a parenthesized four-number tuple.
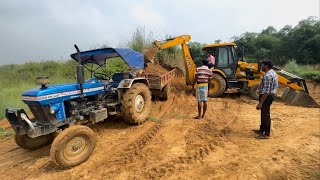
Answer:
(0, 80, 320, 179)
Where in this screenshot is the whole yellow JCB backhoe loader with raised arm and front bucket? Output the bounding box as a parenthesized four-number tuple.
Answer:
(147, 35, 320, 107)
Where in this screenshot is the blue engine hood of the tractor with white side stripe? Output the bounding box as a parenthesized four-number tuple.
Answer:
(22, 79, 104, 105)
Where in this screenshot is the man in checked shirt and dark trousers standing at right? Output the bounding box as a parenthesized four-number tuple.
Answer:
(254, 60, 278, 139)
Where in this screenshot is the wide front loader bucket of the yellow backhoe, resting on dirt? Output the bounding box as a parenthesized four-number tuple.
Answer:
(281, 88, 320, 108)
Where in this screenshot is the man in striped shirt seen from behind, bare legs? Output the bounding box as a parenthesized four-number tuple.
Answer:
(195, 59, 212, 119)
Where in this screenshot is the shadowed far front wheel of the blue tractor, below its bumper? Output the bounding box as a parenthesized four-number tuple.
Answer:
(14, 134, 53, 150)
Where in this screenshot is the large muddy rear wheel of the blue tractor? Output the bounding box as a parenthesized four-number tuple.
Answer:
(121, 83, 151, 124)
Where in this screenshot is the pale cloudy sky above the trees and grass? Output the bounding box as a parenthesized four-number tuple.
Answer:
(0, 0, 320, 65)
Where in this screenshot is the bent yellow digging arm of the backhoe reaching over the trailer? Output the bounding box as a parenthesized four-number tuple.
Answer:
(153, 35, 197, 85)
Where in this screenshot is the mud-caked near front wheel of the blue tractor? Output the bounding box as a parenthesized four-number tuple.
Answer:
(50, 125, 96, 168)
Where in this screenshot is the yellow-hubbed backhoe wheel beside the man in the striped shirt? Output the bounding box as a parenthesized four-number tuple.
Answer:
(208, 73, 227, 97)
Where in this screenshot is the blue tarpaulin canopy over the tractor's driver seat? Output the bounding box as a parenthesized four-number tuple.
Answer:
(71, 48, 144, 69)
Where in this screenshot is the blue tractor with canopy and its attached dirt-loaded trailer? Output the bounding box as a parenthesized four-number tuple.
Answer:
(6, 45, 174, 168)
